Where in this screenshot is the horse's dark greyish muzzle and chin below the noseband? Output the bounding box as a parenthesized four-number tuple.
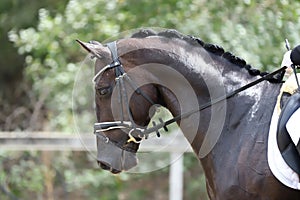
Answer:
(97, 137, 138, 174)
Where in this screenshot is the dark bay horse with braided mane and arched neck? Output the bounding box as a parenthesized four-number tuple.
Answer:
(79, 30, 300, 200)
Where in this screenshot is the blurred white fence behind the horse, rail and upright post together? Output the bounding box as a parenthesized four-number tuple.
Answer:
(0, 131, 192, 200)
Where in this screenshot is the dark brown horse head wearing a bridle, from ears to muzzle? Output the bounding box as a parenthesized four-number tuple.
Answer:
(78, 40, 163, 173)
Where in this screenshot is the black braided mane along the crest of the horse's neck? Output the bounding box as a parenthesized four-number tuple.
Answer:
(131, 29, 284, 83)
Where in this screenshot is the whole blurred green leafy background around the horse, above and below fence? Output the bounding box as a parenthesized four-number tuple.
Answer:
(0, 0, 300, 200)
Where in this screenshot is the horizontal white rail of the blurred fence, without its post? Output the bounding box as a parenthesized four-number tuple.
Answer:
(0, 131, 192, 153)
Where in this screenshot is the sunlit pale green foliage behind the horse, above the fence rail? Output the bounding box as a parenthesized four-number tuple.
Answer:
(9, 0, 300, 131)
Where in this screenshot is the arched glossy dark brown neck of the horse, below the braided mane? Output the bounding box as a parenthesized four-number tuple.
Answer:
(121, 37, 279, 153)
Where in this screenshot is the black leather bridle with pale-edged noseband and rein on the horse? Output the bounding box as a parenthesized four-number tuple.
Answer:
(93, 41, 287, 146)
